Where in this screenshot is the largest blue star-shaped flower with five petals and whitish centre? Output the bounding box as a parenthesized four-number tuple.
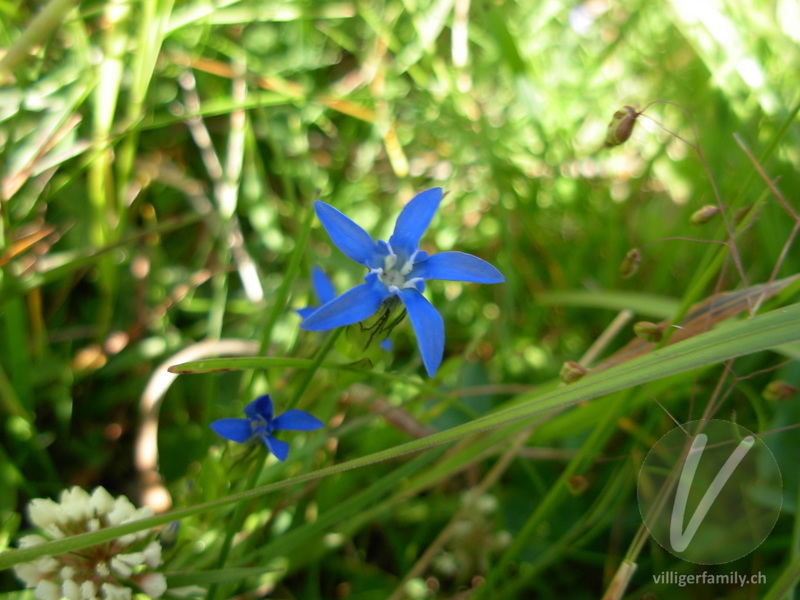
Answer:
(300, 188, 505, 377)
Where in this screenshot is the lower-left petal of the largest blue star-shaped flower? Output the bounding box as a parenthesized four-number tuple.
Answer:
(300, 273, 390, 331)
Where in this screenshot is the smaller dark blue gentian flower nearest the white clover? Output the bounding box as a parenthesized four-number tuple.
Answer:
(211, 394, 325, 461)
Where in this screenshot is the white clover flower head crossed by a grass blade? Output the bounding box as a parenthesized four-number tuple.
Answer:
(14, 486, 167, 600)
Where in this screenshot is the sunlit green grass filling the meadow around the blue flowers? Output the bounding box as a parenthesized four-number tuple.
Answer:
(0, 0, 800, 600)
